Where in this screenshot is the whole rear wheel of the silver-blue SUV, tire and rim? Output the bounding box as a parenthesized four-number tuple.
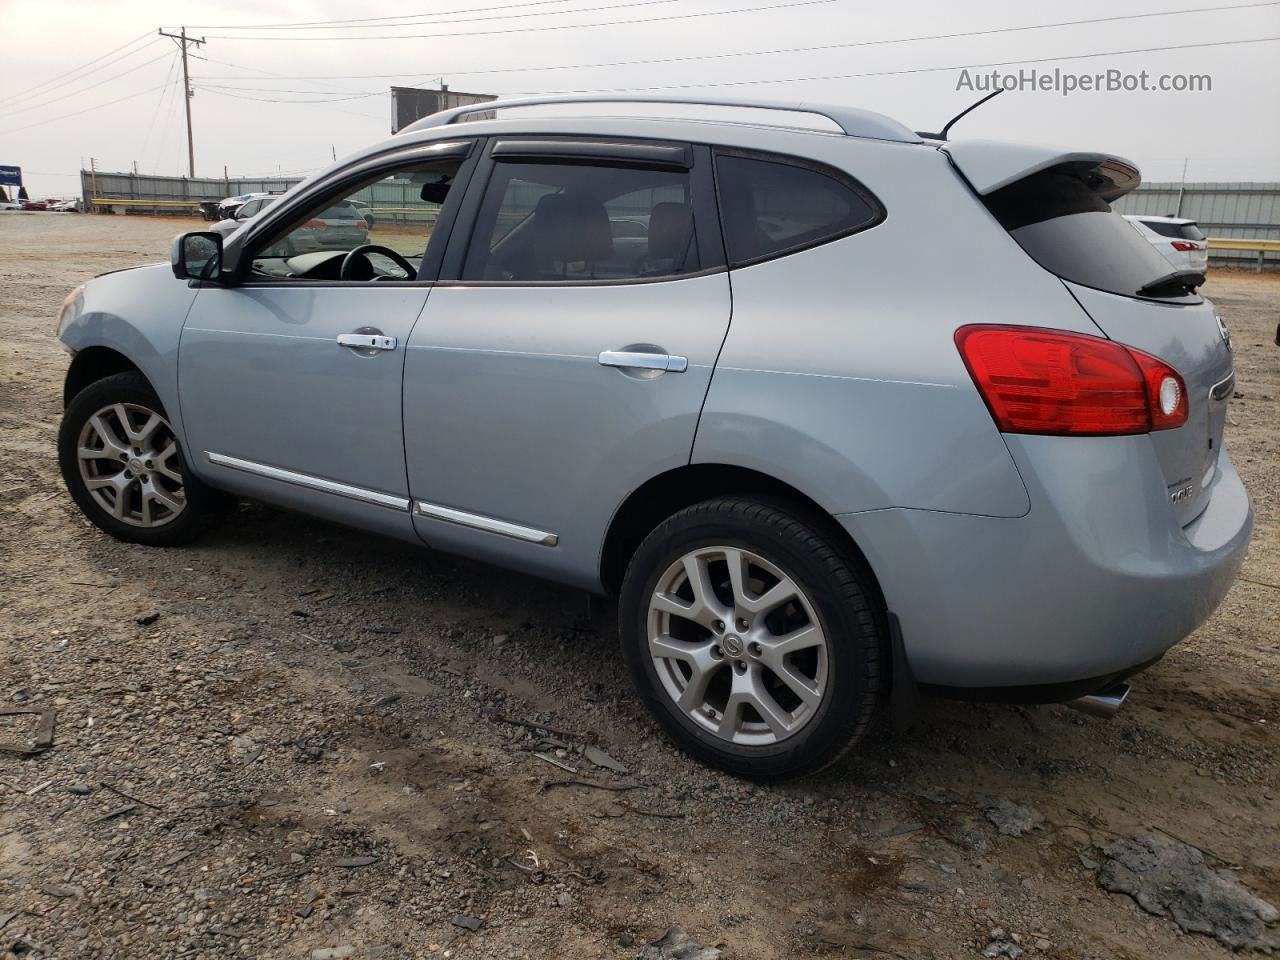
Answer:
(620, 498, 887, 780)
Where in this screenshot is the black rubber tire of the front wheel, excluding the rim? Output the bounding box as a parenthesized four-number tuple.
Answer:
(58, 372, 230, 547)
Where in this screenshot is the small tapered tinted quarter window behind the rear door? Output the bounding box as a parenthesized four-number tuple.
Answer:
(716, 152, 884, 266)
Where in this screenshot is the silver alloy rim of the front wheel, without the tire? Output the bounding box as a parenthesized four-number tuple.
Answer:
(76, 403, 187, 527)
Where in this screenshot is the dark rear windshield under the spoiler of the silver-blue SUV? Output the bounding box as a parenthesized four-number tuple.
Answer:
(984, 166, 1199, 302)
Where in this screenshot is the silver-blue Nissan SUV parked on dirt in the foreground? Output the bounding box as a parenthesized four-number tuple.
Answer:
(58, 97, 1253, 778)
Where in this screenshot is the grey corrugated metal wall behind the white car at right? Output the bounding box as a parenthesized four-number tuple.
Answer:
(1112, 183, 1280, 269)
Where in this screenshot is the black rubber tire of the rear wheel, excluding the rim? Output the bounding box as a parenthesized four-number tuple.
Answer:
(618, 498, 888, 781)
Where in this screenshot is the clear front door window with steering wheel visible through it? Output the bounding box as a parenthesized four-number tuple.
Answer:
(252, 157, 462, 280)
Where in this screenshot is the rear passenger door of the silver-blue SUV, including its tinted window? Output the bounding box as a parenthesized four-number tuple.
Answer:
(404, 138, 730, 588)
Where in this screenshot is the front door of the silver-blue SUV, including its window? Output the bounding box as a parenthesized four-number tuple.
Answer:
(178, 151, 471, 538)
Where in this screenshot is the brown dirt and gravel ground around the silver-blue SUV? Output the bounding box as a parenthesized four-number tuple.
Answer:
(0, 214, 1280, 960)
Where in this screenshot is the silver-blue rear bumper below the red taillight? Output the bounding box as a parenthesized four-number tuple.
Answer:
(836, 436, 1253, 699)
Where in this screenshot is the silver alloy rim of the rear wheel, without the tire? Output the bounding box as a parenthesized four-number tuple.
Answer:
(648, 547, 829, 746)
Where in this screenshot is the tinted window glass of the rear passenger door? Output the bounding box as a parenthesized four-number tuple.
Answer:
(462, 161, 700, 283)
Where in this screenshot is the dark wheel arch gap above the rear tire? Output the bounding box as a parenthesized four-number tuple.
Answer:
(600, 463, 886, 611)
